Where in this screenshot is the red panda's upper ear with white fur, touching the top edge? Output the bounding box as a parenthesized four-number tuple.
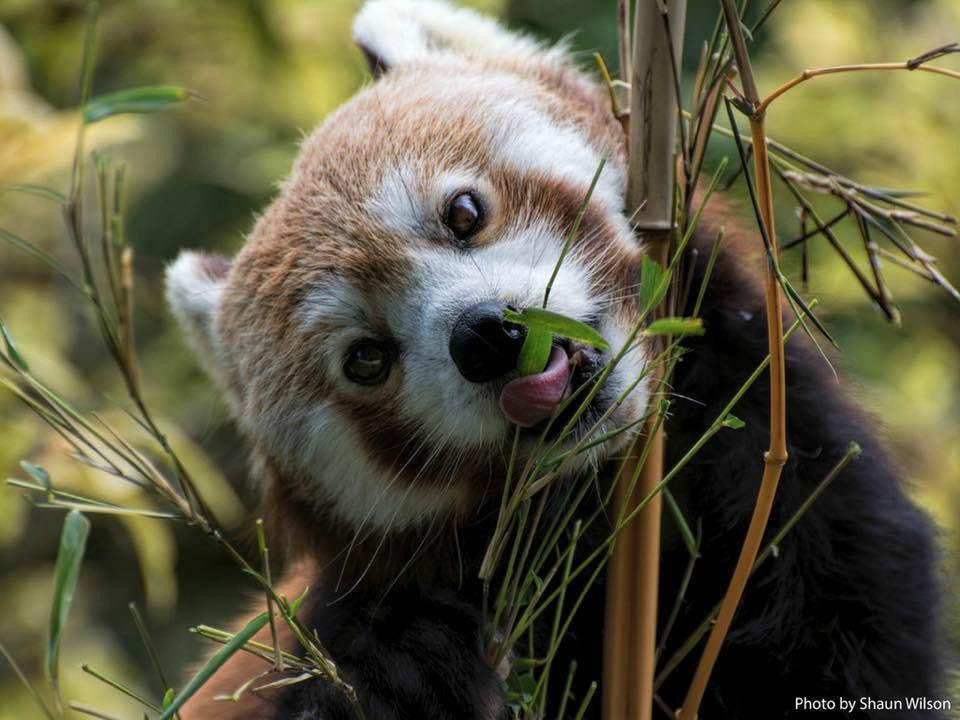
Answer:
(353, 0, 562, 73)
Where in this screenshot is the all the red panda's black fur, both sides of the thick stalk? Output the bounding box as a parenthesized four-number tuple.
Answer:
(277, 231, 945, 720)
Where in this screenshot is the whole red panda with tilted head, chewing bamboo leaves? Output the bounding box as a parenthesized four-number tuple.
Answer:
(167, 0, 940, 720)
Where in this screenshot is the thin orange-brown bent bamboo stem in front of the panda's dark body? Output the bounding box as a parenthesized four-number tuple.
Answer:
(678, 0, 787, 720)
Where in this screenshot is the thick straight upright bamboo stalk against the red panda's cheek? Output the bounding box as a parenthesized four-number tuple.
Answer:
(603, 0, 686, 720)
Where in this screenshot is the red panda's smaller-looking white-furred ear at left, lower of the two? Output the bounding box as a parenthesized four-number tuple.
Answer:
(166, 250, 230, 400)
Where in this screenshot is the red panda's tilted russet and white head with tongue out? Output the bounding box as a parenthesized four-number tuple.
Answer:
(169, 0, 647, 531)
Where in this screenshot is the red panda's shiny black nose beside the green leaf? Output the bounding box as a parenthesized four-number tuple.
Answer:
(450, 301, 526, 383)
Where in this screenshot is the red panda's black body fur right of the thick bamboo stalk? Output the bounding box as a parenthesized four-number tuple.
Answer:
(661, 228, 944, 720)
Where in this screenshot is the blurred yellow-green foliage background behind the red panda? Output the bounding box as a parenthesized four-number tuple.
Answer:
(0, 0, 960, 720)
